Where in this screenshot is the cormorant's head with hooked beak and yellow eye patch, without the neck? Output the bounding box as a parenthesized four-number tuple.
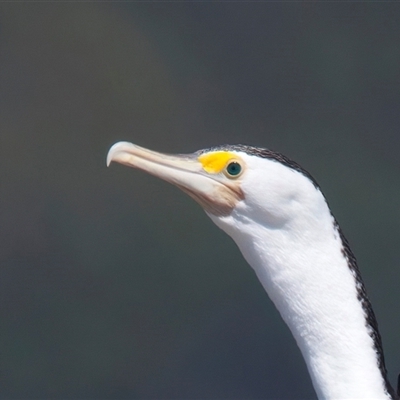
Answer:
(107, 142, 320, 236)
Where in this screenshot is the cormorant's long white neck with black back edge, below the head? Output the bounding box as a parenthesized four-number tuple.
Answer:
(212, 205, 395, 399)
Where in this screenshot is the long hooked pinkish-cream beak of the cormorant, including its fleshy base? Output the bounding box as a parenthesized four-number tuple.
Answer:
(107, 142, 244, 216)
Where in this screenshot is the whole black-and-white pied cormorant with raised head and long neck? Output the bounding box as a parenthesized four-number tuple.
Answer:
(107, 142, 398, 399)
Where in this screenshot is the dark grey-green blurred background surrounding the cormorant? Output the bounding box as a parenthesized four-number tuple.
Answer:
(0, 2, 400, 399)
